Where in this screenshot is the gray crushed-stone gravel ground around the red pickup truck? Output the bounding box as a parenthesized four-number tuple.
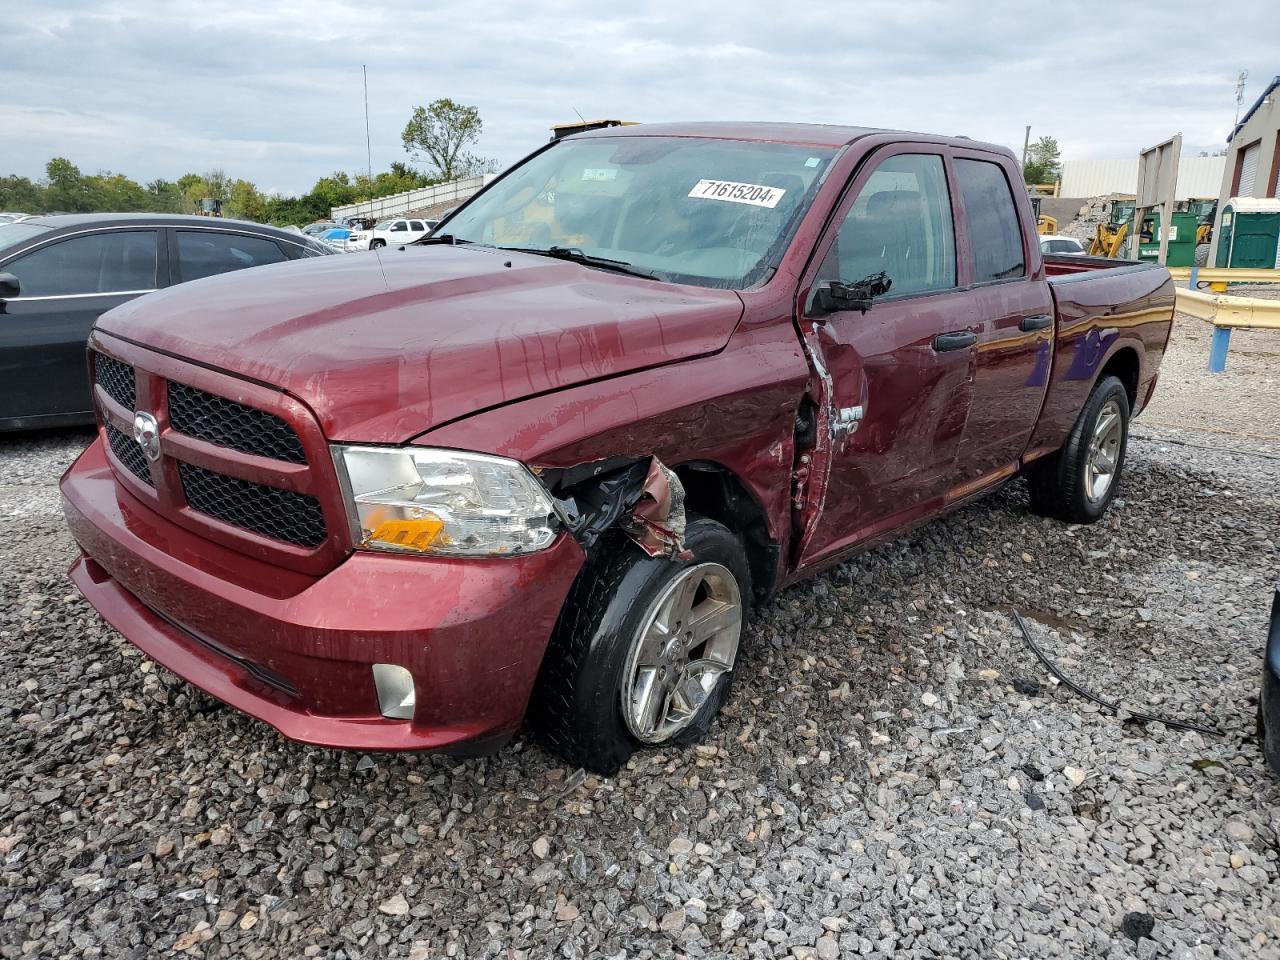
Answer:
(0, 335, 1280, 960)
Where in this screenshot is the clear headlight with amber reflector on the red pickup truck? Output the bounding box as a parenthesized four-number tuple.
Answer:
(333, 444, 556, 557)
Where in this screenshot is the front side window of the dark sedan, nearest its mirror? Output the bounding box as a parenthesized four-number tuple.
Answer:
(5, 230, 156, 297)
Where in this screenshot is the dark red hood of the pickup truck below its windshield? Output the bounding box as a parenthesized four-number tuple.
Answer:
(99, 246, 742, 443)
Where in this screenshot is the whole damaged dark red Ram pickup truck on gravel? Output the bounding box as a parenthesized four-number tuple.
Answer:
(61, 124, 1174, 772)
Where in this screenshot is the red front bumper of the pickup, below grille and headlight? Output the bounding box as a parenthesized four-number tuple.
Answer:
(61, 440, 584, 750)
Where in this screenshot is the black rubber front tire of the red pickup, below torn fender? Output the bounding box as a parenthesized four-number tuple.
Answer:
(527, 518, 751, 776)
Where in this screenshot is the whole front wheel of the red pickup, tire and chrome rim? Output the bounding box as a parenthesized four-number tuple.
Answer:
(529, 518, 751, 774)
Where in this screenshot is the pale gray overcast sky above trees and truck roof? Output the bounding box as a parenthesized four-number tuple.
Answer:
(0, 0, 1280, 193)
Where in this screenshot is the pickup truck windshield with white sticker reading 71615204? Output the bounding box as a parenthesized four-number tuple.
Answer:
(443, 137, 835, 289)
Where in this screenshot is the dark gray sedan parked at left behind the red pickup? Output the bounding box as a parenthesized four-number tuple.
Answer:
(0, 214, 333, 431)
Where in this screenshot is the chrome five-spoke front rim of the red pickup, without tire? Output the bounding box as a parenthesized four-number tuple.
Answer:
(621, 563, 742, 744)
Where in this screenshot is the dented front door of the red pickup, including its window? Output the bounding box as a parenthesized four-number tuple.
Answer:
(795, 145, 982, 567)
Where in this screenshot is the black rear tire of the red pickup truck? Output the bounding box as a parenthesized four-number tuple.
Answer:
(1027, 376, 1129, 524)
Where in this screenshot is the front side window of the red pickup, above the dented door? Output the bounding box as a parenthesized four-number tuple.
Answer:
(822, 154, 956, 297)
